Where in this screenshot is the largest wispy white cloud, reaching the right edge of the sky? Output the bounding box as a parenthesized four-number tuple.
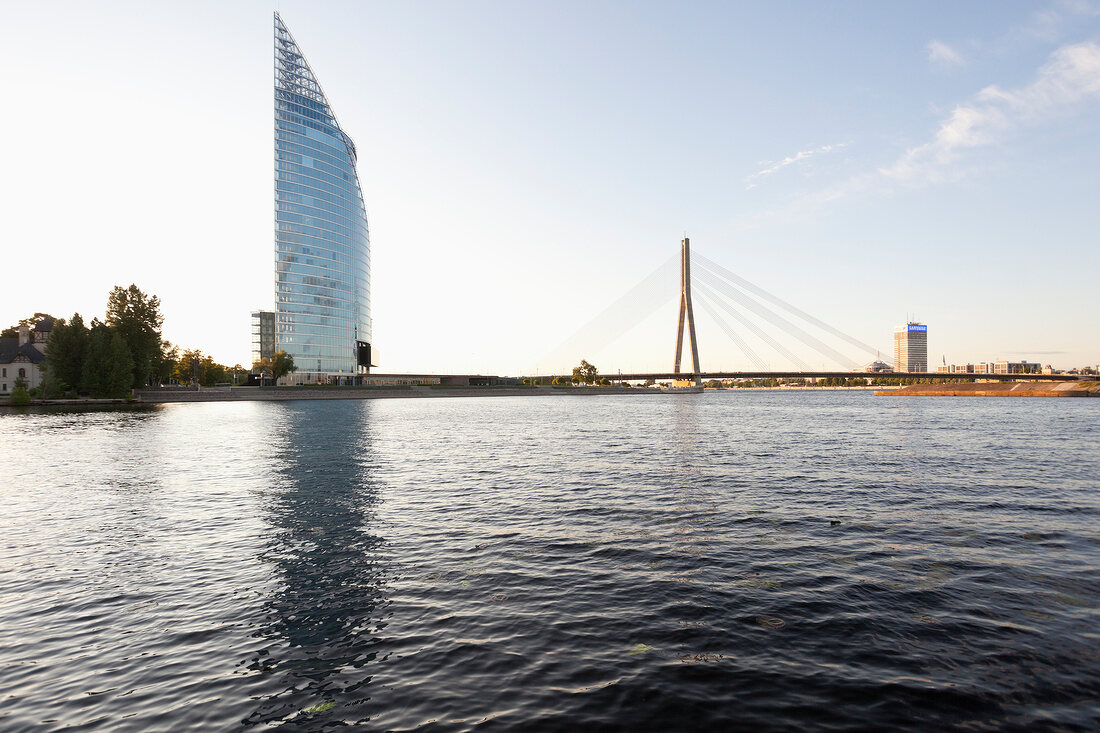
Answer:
(880, 43, 1100, 180)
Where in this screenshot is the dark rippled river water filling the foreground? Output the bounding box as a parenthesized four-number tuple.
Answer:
(0, 392, 1100, 731)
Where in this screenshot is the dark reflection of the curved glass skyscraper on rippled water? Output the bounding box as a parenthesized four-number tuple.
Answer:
(242, 400, 389, 725)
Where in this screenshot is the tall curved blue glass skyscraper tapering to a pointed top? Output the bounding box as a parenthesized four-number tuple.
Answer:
(275, 13, 371, 381)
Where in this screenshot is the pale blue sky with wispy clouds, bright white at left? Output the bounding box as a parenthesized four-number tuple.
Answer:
(0, 0, 1100, 374)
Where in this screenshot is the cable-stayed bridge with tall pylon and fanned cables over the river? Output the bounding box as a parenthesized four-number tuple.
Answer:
(542, 238, 1066, 384)
